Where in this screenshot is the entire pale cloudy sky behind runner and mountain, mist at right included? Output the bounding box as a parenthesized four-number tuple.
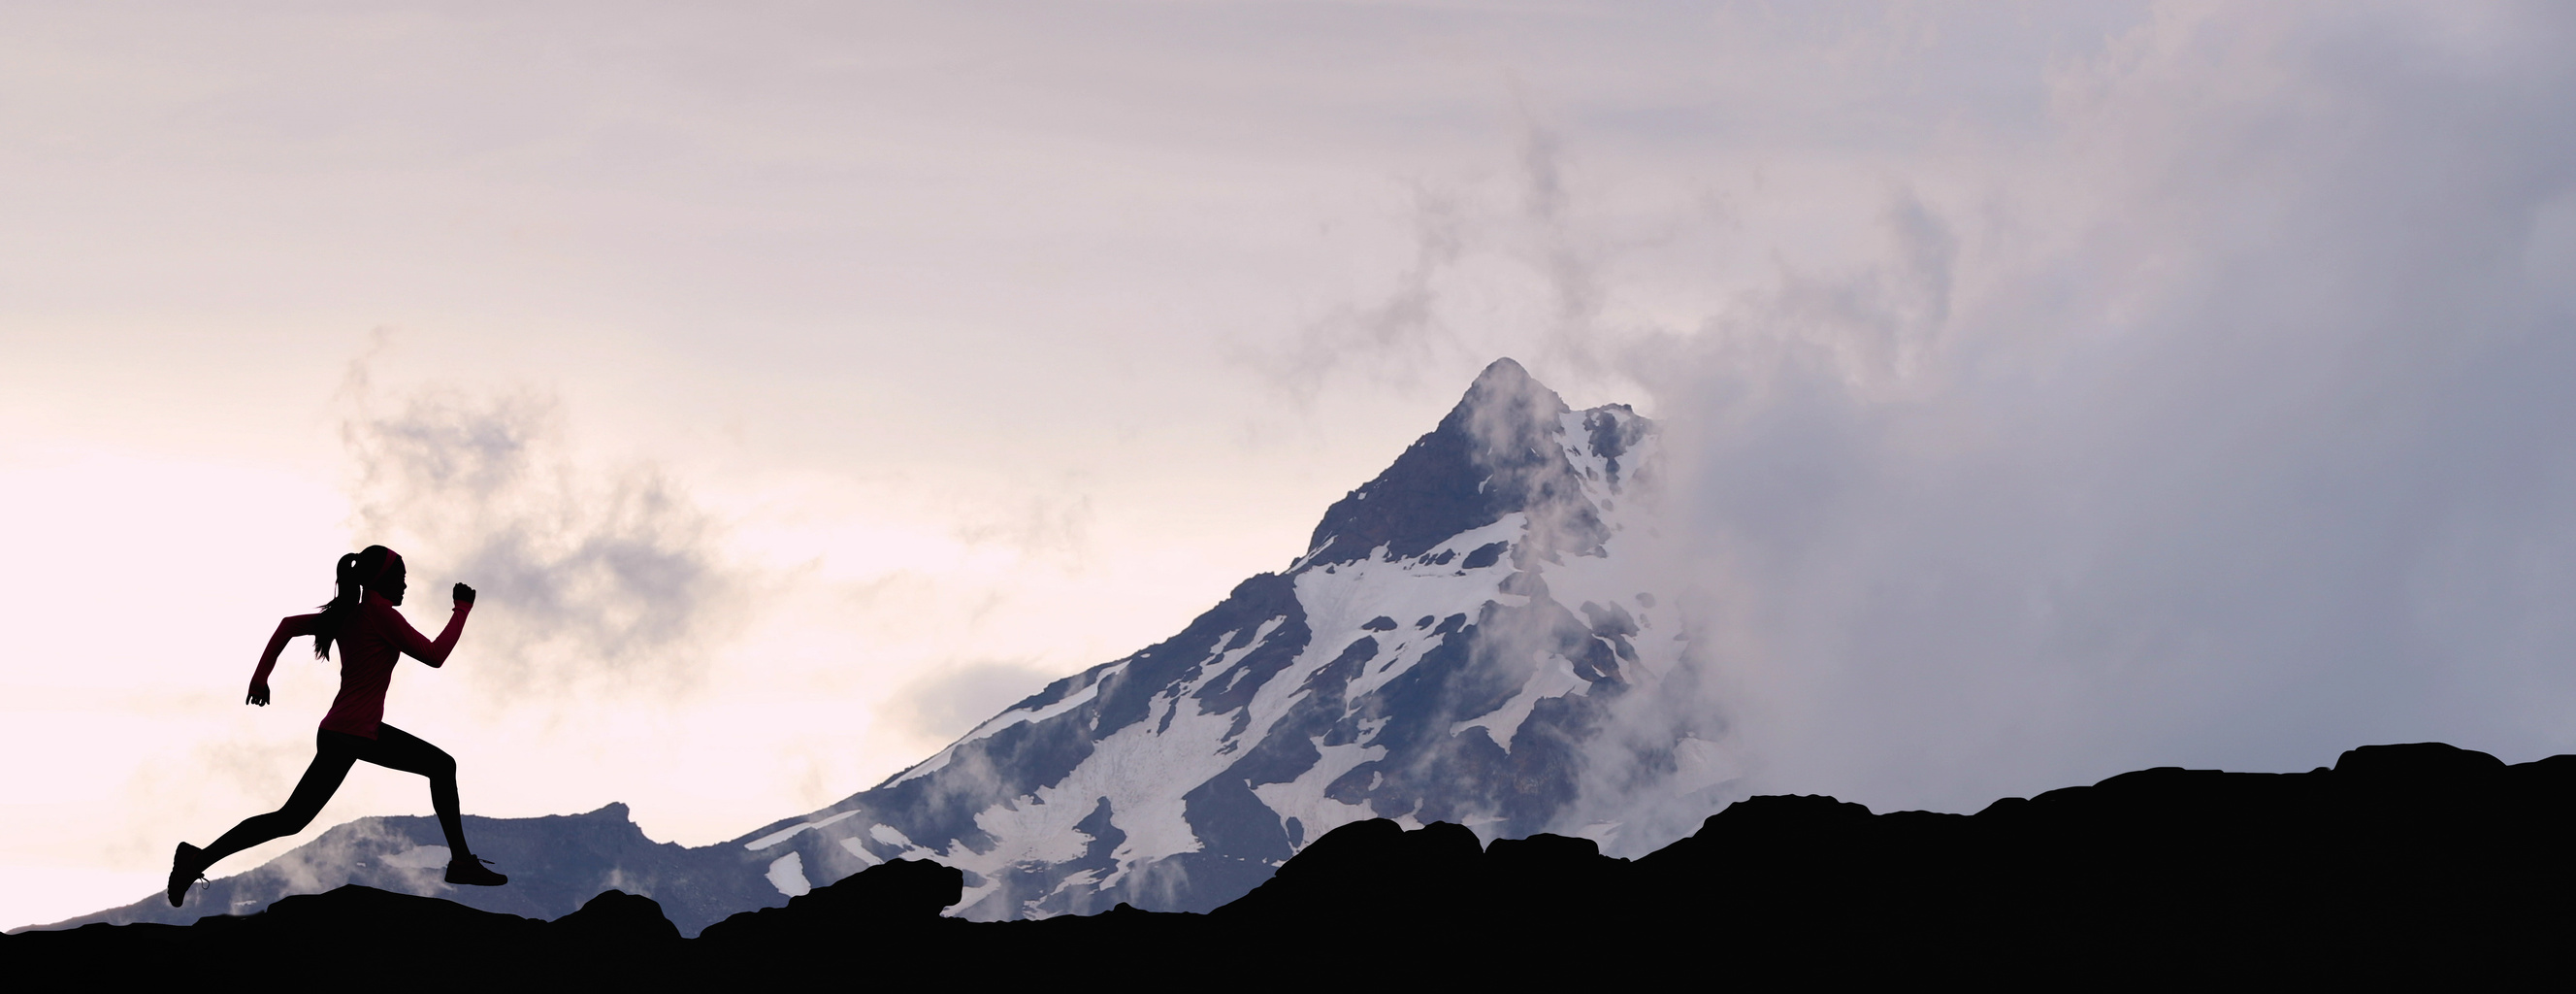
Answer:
(0, 0, 2576, 924)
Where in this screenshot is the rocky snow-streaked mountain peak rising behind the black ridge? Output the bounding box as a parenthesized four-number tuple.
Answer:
(744, 358, 1682, 919)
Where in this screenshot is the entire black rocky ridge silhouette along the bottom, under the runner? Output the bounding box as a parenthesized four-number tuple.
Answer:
(19, 745, 2576, 986)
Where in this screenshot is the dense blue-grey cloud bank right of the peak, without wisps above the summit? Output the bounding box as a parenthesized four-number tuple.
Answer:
(1541, 5, 2576, 832)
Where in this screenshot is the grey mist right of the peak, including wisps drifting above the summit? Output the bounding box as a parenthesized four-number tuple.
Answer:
(1267, 5, 2576, 852)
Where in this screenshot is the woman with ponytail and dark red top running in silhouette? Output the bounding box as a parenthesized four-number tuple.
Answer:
(170, 546, 510, 907)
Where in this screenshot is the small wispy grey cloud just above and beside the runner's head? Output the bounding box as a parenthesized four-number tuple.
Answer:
(340, 342, 758, 690)
